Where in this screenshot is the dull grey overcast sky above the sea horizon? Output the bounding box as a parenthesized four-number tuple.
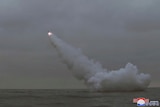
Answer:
(0, 0, 160, 88)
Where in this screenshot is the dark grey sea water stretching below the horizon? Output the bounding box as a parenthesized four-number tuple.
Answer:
(0, 88, 160, 107)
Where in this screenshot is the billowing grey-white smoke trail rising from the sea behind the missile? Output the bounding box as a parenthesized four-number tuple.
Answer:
(50, 35, 150, 91)
